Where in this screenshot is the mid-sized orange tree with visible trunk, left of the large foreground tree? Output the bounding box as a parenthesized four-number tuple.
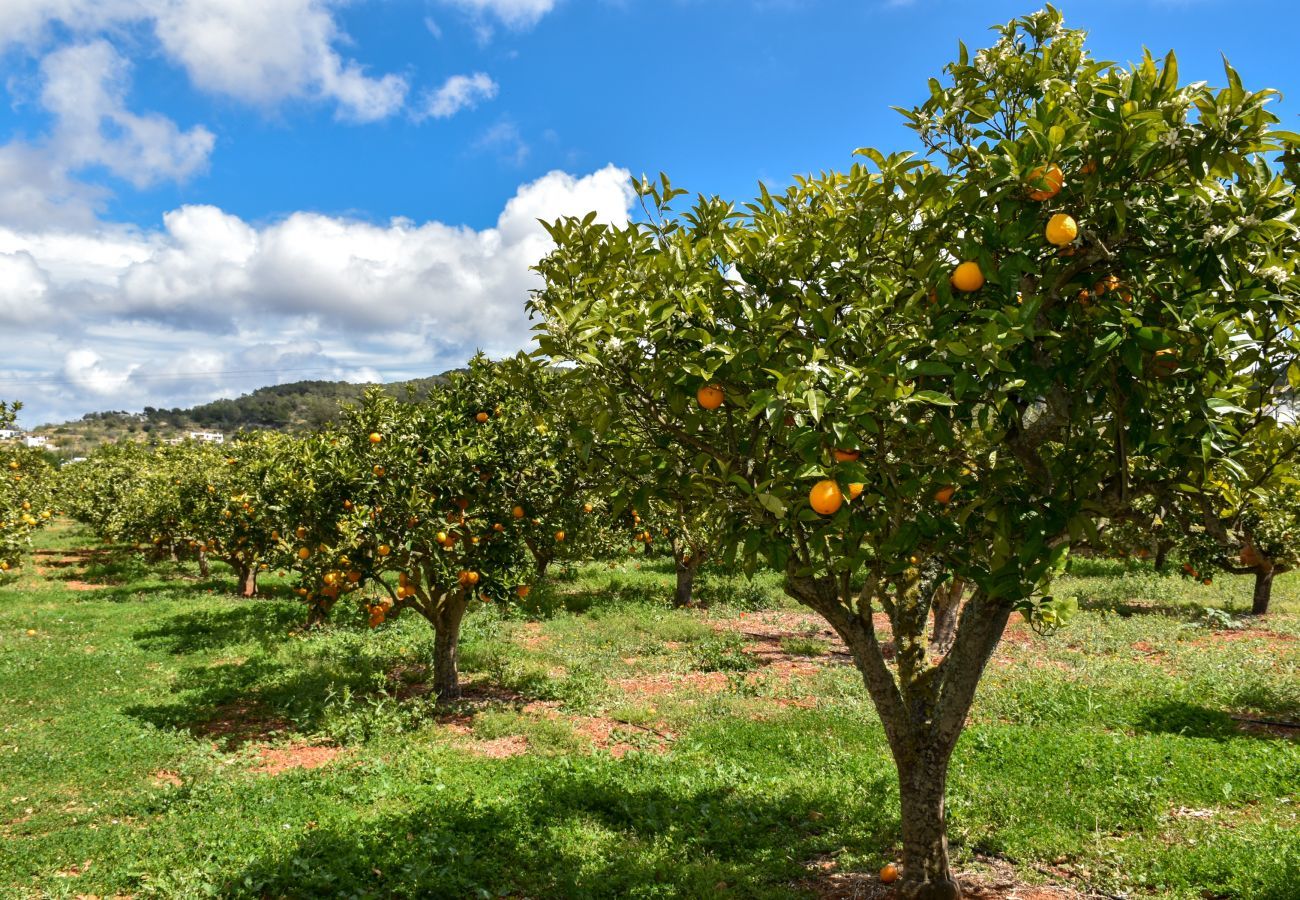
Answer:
(285, 359, 533, 701)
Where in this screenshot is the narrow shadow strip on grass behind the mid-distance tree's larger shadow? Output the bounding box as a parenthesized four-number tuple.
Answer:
(131, 600, 303, 654)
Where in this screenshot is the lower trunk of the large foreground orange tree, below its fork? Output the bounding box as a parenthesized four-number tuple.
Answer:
(894, 741, 962, 900)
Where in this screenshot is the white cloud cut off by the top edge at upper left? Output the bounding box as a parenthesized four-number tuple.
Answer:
(0, 0, 407, 122)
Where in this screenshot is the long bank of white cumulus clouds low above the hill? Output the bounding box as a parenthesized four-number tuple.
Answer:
(0, 165, 634, 424)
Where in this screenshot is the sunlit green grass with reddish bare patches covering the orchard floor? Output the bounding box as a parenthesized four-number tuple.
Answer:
(0, 524, 1300, 900)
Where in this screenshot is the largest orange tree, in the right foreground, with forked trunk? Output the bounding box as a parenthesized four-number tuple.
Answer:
(532, 8, 1300, 897)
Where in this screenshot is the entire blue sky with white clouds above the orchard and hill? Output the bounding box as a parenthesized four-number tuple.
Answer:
(0, 0, 1300, 425)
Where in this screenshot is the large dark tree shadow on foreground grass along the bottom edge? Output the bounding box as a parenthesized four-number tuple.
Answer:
(222, 757, 897, 897)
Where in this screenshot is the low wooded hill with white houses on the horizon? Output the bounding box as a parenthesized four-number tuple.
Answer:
(34, 375, 445, 458)
